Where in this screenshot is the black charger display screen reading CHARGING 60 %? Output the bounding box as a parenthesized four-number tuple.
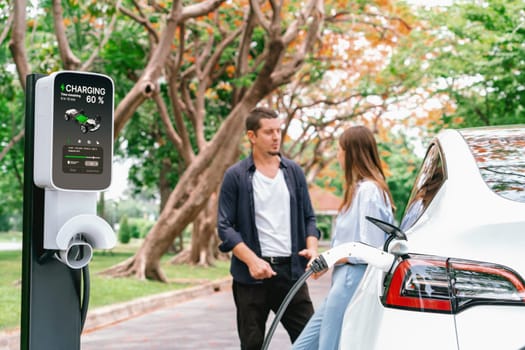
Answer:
(52, 72, 113, 190)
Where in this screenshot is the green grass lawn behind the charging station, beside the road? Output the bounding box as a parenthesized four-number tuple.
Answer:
(0, 243, 229, 331)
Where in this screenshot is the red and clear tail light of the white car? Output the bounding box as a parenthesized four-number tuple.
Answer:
(383, 255, 525, 313)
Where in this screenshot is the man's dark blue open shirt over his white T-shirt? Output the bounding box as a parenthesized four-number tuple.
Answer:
(217, 155, 320, 284)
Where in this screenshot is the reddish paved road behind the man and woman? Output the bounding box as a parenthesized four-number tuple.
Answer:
(81, 273, 330, 350)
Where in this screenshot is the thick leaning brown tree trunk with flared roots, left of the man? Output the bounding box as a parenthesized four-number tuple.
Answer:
(103, 102, 254, 282)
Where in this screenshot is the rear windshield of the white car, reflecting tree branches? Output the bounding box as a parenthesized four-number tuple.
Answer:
(461, 127, 525, 202)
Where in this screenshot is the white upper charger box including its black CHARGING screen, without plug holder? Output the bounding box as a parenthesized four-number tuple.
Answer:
(33, 71, 114, 192)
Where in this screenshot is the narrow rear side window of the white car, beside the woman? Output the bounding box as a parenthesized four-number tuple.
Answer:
(401, 144, 445, 231)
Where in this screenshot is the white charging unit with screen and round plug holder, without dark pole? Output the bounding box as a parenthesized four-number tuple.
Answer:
(34, 71, 116, 268)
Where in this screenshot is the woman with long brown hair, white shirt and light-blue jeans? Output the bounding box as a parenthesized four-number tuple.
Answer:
(292, 126, 394, 350)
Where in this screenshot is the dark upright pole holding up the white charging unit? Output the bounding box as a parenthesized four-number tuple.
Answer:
(20, 74, 81, 350)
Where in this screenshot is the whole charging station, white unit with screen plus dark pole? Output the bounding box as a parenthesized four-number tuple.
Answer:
(21, 71, 116, 350)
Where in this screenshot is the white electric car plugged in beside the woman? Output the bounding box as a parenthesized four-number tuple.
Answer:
(340, 125, 525, 350)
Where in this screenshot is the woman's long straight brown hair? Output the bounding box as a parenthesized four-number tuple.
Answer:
(339, 125, 395, 211)
